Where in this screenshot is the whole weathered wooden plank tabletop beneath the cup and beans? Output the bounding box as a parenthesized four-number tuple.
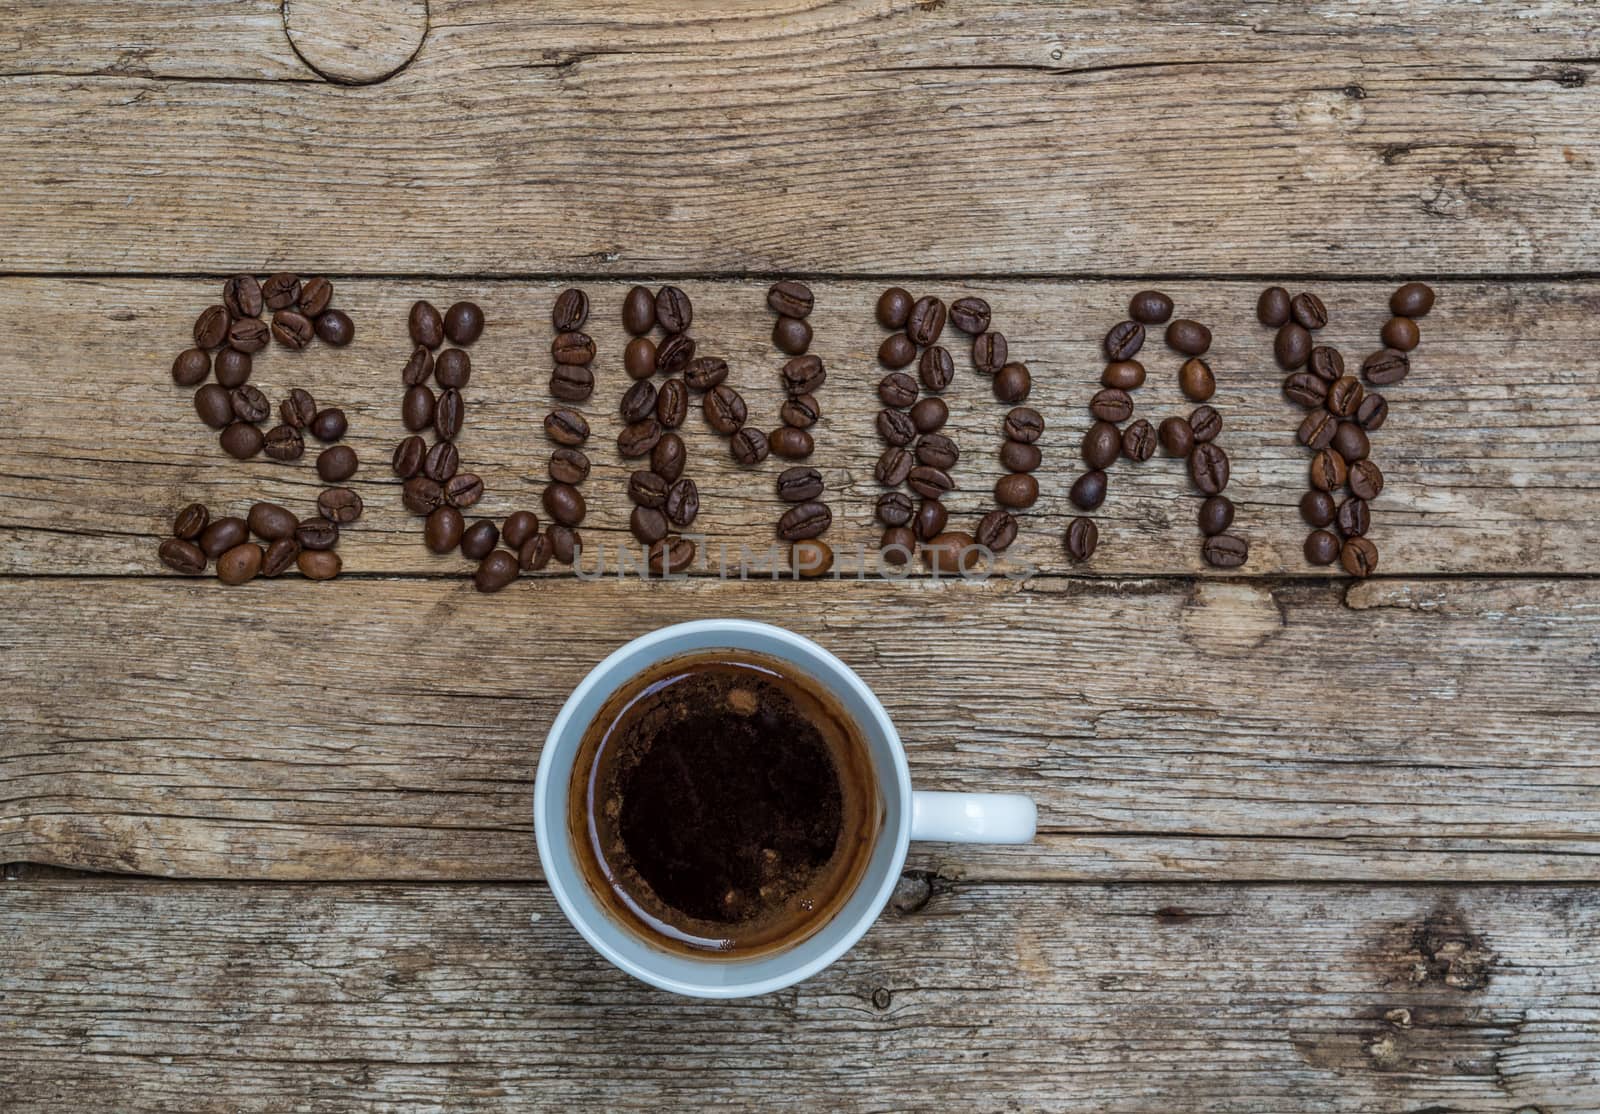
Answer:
(0, 0, 1600, 1114)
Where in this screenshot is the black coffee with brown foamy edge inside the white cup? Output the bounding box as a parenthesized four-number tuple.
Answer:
(568, 650, 883, 957)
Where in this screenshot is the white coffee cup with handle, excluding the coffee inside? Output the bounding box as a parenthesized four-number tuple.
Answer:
(533, 619, 1035, 999)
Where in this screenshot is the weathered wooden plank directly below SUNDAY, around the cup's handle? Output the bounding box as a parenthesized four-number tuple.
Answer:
(0, 578, 1600, 880)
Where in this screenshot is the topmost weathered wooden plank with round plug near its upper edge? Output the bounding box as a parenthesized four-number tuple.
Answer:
(0, 0, 1600, 275)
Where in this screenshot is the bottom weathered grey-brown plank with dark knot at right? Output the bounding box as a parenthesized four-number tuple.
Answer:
(0, 882, 1600, 1114)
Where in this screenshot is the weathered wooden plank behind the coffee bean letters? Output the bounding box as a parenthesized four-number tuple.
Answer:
(0, 279, 1600, 576)
